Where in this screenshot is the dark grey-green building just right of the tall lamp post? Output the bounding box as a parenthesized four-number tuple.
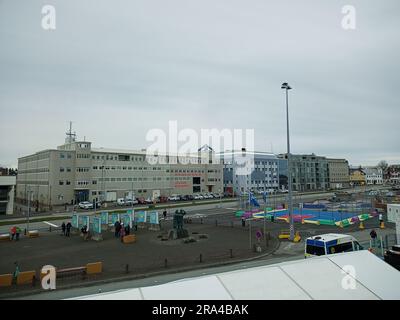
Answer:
(279, 154, 330, 191)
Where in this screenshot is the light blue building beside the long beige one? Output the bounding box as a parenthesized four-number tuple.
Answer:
(220, 149, 285, 195)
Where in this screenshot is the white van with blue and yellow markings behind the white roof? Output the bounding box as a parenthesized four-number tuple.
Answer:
(305, 233, 364, 258)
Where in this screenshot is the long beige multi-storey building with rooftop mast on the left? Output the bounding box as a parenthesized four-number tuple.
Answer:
(16, 135, 223, 210)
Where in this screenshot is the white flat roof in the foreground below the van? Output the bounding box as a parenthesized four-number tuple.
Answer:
(69, 250, 400, 300)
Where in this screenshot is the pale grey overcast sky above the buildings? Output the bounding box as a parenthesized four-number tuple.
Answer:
(0, 0, 400, 166)
